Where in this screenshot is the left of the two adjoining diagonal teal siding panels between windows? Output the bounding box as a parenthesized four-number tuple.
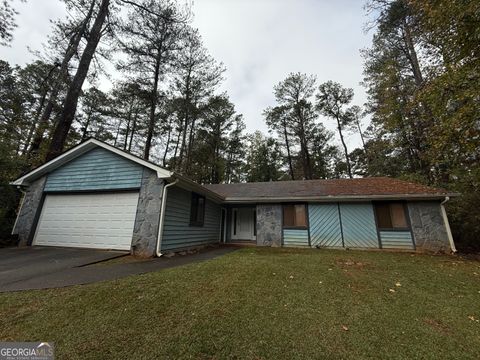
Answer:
(308, 204, 343, 247)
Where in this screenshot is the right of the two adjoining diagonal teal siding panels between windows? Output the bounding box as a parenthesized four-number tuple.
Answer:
(340, 203, 379, 248)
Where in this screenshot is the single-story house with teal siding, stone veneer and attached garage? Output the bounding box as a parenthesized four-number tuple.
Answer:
(12, 139, 455, 257)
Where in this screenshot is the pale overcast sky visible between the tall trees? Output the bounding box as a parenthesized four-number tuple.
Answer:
(0, 0, 371, 145)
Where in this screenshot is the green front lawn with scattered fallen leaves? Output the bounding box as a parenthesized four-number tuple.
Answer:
(0, 248, 480, 359)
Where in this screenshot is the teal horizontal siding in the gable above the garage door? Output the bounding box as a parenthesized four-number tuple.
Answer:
(45, 148, 143, 191)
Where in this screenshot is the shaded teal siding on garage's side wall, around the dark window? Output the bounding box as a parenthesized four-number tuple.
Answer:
(162, 187, 222, 250)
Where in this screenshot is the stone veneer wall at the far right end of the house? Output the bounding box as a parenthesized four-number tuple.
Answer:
(408, 201, 451, 252)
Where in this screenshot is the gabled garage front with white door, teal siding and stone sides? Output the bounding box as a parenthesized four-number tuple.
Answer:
(13, 139, 172, 256)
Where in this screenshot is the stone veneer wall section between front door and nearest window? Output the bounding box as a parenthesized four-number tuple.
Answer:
(257, 204, 282, 246)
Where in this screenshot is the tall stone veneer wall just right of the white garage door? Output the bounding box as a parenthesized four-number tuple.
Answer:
(132, 168, 164, 257)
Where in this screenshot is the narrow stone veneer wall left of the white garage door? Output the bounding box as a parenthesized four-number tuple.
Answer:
(12, 176, 47, 246)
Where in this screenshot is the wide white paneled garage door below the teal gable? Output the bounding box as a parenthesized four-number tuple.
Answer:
(33, 192, 138, 250)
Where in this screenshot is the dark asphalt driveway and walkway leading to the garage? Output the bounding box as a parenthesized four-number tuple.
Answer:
(0, 247, 235, 292)
